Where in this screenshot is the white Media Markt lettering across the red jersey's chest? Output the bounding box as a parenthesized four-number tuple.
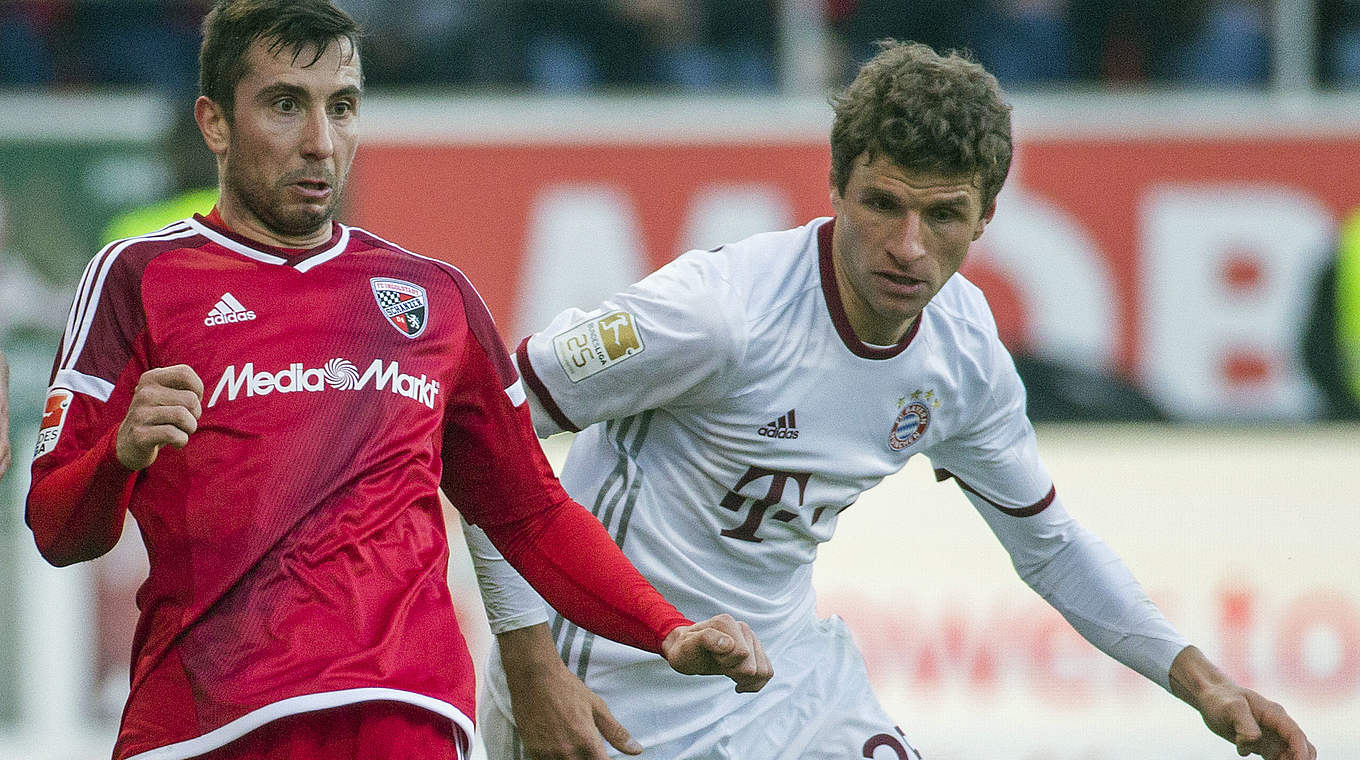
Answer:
(208, 358, 439, 409)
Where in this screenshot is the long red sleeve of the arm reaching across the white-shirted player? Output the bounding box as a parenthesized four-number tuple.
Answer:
(441, 273, 690, 653)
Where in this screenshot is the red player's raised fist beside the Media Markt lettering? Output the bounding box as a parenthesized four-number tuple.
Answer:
(114, 364, 203, 470)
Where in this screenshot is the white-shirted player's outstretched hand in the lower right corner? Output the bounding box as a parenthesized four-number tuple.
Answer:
(1171, 647, 1318, 760)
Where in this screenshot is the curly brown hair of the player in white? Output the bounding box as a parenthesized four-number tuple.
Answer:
(831, 39, 1012, 209)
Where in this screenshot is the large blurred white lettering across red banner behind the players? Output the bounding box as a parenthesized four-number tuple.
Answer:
(513, 182, 1334, 420)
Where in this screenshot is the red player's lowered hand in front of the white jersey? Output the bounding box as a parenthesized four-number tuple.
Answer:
(661, 615, 774, 692)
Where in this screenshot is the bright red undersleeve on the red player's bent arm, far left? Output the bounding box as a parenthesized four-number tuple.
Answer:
(26, 430, 135, 567)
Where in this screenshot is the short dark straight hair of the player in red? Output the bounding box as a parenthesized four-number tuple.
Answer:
(199, 0, 362, 121)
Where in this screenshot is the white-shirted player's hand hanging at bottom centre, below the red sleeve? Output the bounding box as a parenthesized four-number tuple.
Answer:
(498, 624, 642, 760)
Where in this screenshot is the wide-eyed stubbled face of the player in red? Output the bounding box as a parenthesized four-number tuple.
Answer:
(204, 39, 362, 247)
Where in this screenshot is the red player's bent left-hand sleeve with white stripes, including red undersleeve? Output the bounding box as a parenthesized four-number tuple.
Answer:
(24, 241, 163, 566)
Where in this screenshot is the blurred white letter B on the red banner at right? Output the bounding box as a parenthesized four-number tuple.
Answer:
(1140, 184, 1336, 419)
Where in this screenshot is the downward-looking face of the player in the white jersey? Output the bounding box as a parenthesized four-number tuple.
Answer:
(831, 156, 996, 345)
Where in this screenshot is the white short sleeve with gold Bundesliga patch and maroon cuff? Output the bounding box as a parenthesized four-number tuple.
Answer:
(515, 252, 745, 435)
